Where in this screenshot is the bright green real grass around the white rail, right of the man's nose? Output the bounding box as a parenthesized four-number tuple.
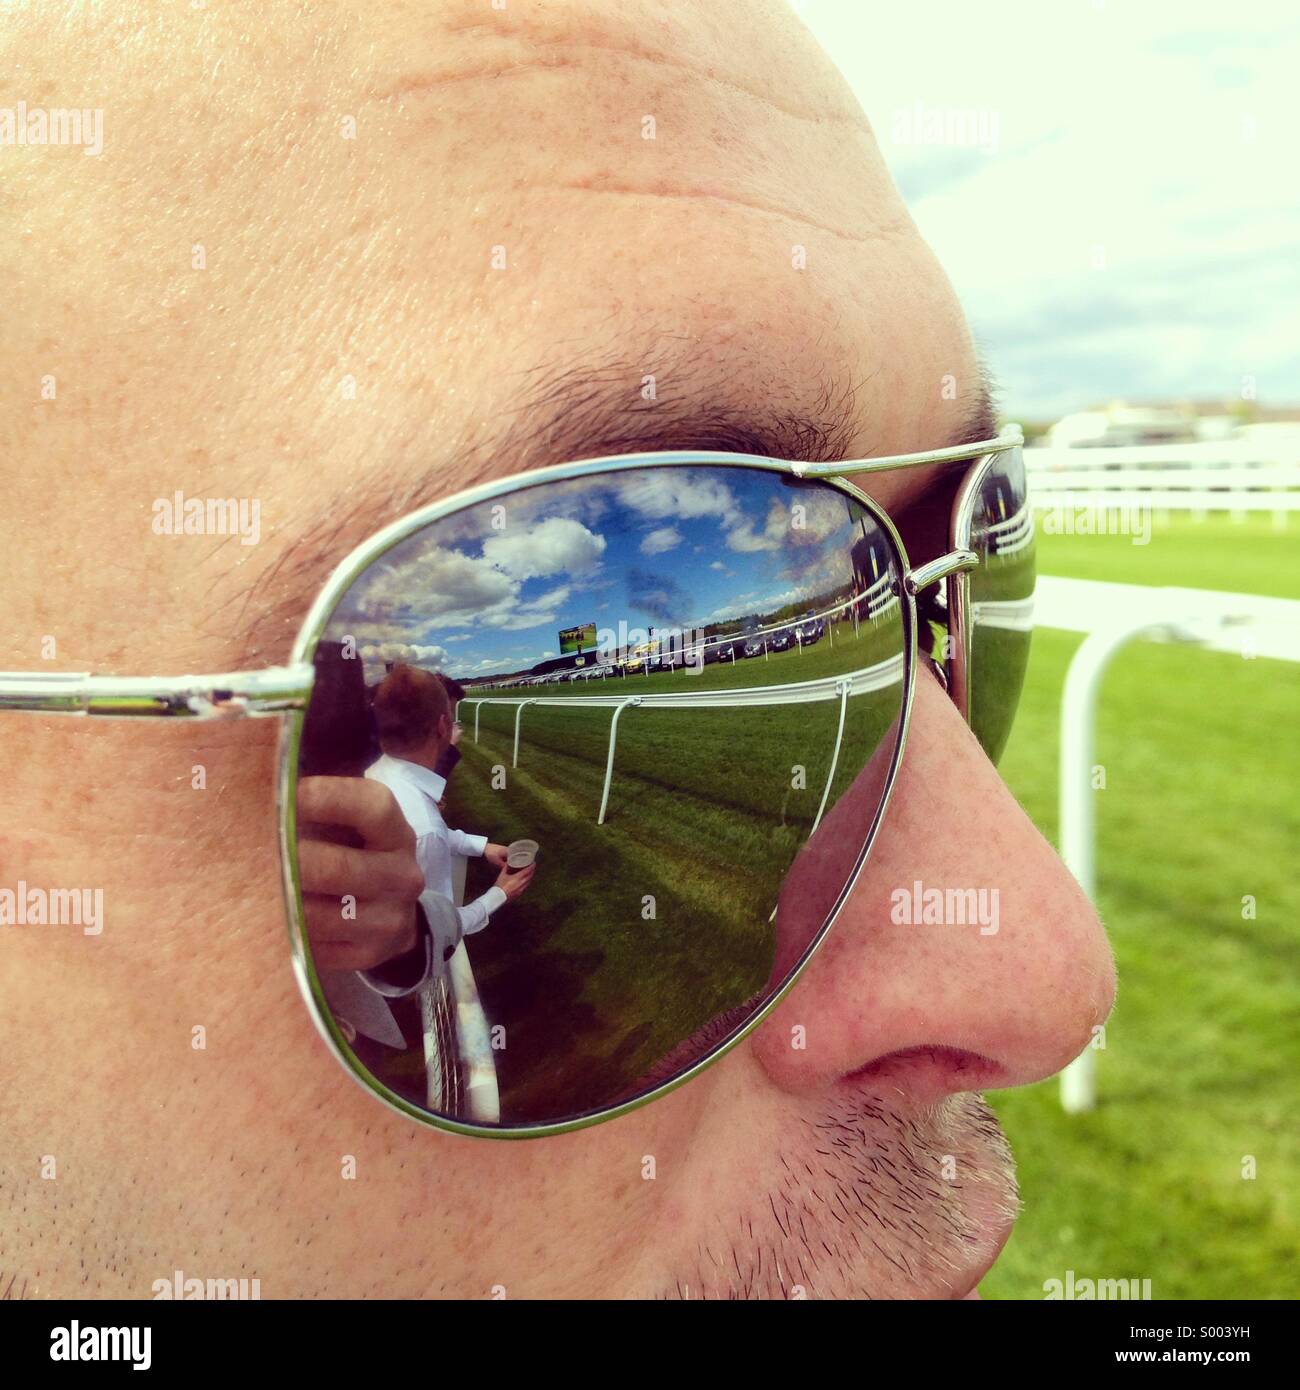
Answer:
(983, 517, 1300, 1298)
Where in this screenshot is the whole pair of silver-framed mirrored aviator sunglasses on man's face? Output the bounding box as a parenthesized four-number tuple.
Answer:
(0, 427, 1034, 1138)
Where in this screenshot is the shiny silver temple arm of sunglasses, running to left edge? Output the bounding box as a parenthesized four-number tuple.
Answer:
(0, 663, 316, 720)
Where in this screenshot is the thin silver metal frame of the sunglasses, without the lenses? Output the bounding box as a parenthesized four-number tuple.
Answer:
(0, 425, 1023, 1138)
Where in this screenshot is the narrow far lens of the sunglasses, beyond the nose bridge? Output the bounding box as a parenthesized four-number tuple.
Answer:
(970, 449, 1036, 762)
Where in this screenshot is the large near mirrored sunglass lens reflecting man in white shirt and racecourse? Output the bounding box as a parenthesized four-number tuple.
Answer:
(299, 464, 905, 1126)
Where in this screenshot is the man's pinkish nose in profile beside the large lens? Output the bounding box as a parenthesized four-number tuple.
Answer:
(752, 673, 1115, 1104)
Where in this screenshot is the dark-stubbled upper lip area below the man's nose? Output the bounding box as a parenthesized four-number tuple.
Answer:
(656, 1086, 1019, 1300)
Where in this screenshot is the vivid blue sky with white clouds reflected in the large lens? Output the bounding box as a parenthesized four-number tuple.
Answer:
(325, 467, 861, 680)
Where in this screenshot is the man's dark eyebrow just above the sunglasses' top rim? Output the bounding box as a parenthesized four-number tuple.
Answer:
(235, 338, 997, 663)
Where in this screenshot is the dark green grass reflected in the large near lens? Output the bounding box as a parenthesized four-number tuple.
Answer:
(448, 608, 901, 1119)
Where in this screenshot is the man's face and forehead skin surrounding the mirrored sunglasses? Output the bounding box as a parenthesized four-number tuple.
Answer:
(0, 0, 1114, 1297)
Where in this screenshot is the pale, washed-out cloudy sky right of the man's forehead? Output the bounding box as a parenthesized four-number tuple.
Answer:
(794, 0, 1300, 420)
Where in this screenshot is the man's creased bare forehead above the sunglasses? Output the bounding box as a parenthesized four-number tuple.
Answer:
(0, 0, 976, 669)
